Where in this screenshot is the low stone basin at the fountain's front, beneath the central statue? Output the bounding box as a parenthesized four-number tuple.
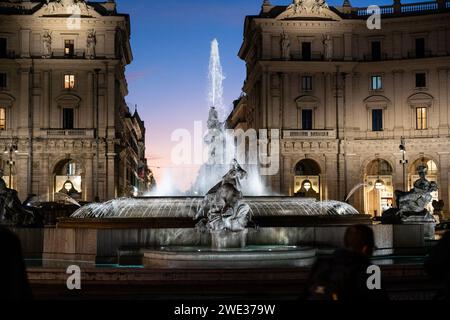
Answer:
(143, 246, 317, 269)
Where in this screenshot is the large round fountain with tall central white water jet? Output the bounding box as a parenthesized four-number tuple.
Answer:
(54, 40, 370, 268)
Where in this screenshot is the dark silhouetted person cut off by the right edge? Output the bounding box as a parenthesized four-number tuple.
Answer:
(425, 232, 450, 301)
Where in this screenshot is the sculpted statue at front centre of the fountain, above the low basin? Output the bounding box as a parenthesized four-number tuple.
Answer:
(194, 160, 255, 232)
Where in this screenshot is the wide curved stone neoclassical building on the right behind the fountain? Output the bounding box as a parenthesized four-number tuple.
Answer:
(228, 0, 450, 215)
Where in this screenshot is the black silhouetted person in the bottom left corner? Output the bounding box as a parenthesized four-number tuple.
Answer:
(0, 227, 32, 301)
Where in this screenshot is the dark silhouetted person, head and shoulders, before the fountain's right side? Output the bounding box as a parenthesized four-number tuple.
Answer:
(307, 225, 387, 301)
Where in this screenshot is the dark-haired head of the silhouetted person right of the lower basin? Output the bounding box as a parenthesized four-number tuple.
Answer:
(344, 225, 375, 257)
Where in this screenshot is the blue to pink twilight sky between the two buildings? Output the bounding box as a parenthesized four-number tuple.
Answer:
(117, 0, 426, 190)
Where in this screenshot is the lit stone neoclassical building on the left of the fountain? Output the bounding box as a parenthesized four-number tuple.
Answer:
(0, 0, 153, 201)
